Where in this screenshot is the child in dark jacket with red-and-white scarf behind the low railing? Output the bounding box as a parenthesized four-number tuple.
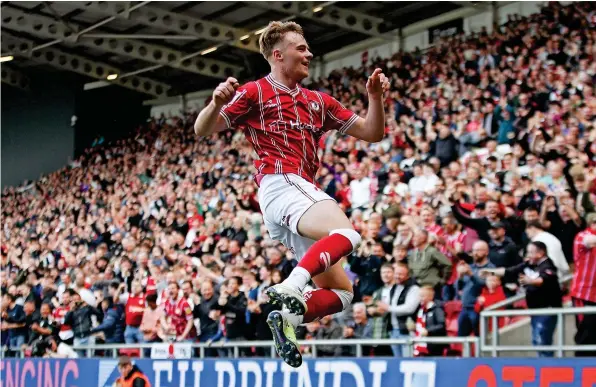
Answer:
(410, 286, 447, 356)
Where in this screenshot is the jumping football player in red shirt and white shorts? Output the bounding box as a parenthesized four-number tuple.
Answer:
(194, 22, 389, 367)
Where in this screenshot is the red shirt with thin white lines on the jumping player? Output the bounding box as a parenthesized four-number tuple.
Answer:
(220, 75, 358, 182)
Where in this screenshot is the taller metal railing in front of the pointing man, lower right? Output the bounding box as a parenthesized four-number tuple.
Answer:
(480, 306, 596, 357)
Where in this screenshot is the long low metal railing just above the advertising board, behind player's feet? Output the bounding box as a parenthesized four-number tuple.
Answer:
(8, 337, 479, 358)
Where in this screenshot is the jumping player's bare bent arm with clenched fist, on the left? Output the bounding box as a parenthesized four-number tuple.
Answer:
(195, 77, 239, 136)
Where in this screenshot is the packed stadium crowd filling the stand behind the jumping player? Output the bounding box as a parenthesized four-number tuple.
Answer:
(0, 2, 596, 356)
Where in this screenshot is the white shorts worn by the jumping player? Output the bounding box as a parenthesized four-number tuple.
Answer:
(258, 173, 334, 260)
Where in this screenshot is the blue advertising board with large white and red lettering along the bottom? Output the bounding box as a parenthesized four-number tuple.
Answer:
(0, 358, 596, 387)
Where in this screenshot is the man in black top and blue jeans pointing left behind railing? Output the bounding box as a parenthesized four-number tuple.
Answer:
(480, 241, 563, 357)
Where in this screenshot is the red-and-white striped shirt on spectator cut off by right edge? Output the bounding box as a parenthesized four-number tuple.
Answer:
(570, 228, 596, 302)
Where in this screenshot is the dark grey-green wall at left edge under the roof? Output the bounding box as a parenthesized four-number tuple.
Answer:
(1, 72, 77, 187)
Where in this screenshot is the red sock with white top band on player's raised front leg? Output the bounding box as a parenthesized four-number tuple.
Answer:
(298, 234, 354, 278)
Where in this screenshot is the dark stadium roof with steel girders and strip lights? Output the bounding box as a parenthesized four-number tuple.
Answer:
(1, 1, 474, 97)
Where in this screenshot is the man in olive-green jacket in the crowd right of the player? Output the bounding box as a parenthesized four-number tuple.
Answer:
(408, 230, 452, 291)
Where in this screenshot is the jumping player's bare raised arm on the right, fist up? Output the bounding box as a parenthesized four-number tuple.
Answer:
(346, 69, 389, 142)
